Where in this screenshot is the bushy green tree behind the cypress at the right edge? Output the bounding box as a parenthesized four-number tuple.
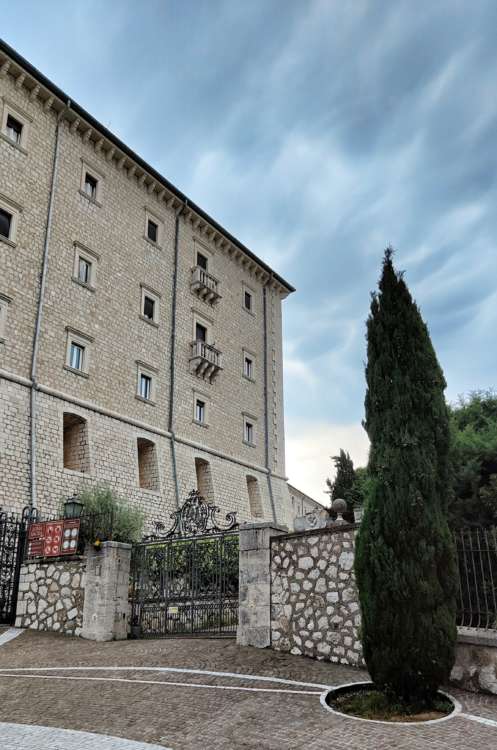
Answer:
(449, 391, 497, 528)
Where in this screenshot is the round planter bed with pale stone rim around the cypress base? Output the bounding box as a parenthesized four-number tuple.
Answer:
(321, 682, 461, 724)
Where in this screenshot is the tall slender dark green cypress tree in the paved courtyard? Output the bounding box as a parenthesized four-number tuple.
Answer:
(355, 248, 457, 702)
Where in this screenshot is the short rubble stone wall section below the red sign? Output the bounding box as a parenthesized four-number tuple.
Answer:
(16, 559, 86, 636)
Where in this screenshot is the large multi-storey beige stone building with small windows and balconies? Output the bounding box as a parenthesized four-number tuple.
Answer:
(0, 42, 293, 523)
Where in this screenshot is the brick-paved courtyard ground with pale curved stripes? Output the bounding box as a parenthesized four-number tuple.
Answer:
(0, 631, 497, 750)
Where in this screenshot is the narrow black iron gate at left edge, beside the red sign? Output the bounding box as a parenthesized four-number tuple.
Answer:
(0, 508, 36, 625)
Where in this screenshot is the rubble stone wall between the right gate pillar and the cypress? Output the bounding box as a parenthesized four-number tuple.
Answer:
(271, 525, 363, 666)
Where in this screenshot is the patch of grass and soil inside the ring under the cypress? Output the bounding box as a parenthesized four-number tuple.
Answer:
(328, 685, 454, 722)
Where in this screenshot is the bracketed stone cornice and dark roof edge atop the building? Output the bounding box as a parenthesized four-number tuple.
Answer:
(0, 40, 295, 297)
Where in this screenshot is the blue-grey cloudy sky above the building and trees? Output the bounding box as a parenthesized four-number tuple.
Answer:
(0, 0, 497, 500)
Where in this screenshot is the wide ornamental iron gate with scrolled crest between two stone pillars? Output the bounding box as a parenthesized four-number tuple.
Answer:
(131, 490, 238, 638)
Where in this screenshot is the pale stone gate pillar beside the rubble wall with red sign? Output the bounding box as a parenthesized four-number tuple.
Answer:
(81, 542, 131, 641)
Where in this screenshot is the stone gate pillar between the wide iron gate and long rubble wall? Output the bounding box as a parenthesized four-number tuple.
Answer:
(236, 521, 288, 648)
